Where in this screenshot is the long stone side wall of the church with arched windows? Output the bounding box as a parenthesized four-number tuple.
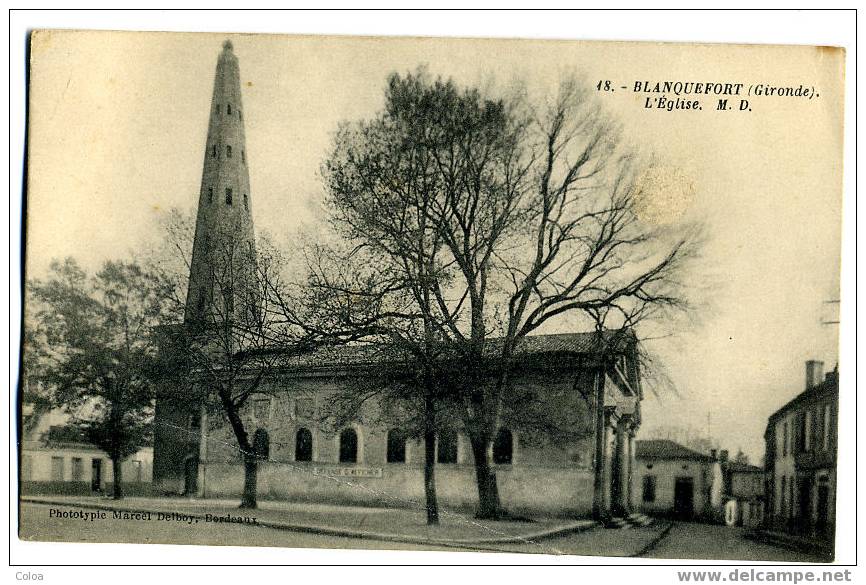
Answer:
(199, 368, 594, 515)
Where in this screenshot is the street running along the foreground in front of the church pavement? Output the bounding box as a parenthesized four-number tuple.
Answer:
(19, 503, 820, 562)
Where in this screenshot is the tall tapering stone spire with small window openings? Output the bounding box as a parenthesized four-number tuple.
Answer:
(184, 40, 255, 322)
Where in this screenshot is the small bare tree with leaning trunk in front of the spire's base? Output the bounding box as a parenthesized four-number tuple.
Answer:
(151, 210, 304, 508)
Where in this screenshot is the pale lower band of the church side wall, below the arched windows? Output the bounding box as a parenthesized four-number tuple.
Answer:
(199, 461, 593, 516)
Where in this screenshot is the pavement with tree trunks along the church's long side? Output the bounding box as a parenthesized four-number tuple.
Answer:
(21, 496, 596, 547)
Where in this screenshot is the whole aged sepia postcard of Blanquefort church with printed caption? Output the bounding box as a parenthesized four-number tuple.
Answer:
(16, 30, 854, 562)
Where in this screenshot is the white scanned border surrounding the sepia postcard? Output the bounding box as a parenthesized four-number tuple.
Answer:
(3, 8, 856, 585)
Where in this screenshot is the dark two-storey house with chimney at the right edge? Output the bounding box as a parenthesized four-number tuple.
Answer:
(764, 360, 839, 541)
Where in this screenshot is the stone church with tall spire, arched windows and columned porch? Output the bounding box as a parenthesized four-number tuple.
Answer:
(153, 41, 642, 517)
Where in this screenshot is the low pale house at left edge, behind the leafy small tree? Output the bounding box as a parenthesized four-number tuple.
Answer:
(20, 403, 153, 495)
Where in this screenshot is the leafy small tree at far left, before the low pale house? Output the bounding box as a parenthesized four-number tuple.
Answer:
(25, 258, 165, 499)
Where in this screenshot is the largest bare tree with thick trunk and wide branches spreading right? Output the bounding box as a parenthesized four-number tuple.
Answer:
(314, 72, 697, 518)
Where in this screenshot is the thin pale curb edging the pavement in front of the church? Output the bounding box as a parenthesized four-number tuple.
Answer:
(20, 497, 598, 547)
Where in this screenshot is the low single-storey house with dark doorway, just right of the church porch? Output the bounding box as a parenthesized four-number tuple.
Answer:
(633, 439, 722, 520)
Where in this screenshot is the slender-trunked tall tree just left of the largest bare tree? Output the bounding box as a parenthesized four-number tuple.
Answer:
(273, 90, 460, 524)
